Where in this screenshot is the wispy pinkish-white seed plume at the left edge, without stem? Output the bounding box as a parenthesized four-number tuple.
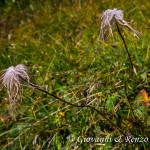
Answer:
(0, 64, 30, 103)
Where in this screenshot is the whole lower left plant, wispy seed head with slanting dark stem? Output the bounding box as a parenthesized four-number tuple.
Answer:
(1, 64, 125, 135)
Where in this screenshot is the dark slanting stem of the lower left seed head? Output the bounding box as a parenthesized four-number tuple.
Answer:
(29, 83, 126, 136)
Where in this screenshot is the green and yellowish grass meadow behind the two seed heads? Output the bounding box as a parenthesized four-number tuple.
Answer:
(0, 0, 150, 150)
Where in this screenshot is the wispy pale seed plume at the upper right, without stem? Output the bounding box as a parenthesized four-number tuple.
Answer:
(100, 8, 142, 40)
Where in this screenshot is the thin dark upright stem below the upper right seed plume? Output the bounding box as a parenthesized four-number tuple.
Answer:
(116, 21, 137, 120)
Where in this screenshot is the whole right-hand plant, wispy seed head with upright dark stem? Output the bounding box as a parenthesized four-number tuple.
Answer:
(100, 8, 142, 121)
